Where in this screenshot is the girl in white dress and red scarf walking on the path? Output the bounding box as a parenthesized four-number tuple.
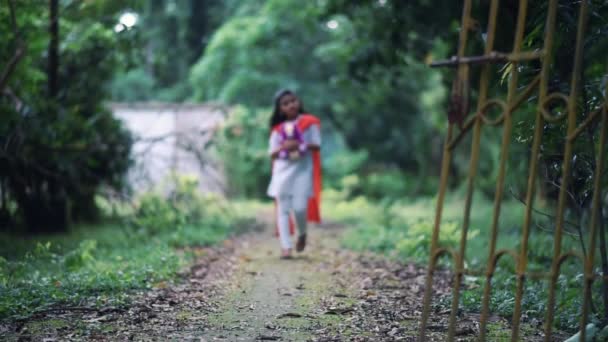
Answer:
(268, 90, 321, 259)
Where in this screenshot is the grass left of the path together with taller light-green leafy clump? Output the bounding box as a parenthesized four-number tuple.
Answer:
(0, 177, 249, 319)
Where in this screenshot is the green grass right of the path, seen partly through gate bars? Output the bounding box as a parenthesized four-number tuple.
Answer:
(324, 192, 601, 331)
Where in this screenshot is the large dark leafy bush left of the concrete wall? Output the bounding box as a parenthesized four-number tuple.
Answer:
(0, 2, 132, 232)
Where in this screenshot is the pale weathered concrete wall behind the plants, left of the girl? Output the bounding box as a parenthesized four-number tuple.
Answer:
(110, 103, 228, 194)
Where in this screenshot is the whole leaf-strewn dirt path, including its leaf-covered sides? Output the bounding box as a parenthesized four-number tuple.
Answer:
(0, 219, 552, 341)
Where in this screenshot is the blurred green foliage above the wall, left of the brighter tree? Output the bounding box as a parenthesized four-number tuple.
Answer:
(112, 0, 226, 102)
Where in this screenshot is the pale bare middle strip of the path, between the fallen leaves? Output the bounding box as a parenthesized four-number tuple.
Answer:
(204, 226, 352, 341)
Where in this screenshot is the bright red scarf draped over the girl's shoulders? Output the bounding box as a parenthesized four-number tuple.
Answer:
(272, 114, 321, 235)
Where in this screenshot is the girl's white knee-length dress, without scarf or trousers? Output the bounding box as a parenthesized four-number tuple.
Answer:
(267, 119, 321, 198)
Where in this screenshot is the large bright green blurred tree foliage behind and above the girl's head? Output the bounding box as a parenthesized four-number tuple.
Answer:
(190, 1, 446, 173)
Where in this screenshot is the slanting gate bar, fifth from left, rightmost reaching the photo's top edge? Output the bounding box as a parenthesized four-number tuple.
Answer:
(545, 0, 587, 342)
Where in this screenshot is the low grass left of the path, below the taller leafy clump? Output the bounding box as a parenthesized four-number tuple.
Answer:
(0, 220, 245, 319)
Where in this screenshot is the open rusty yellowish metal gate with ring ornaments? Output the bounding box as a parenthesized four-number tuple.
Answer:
(419, 0, 608, 341)
